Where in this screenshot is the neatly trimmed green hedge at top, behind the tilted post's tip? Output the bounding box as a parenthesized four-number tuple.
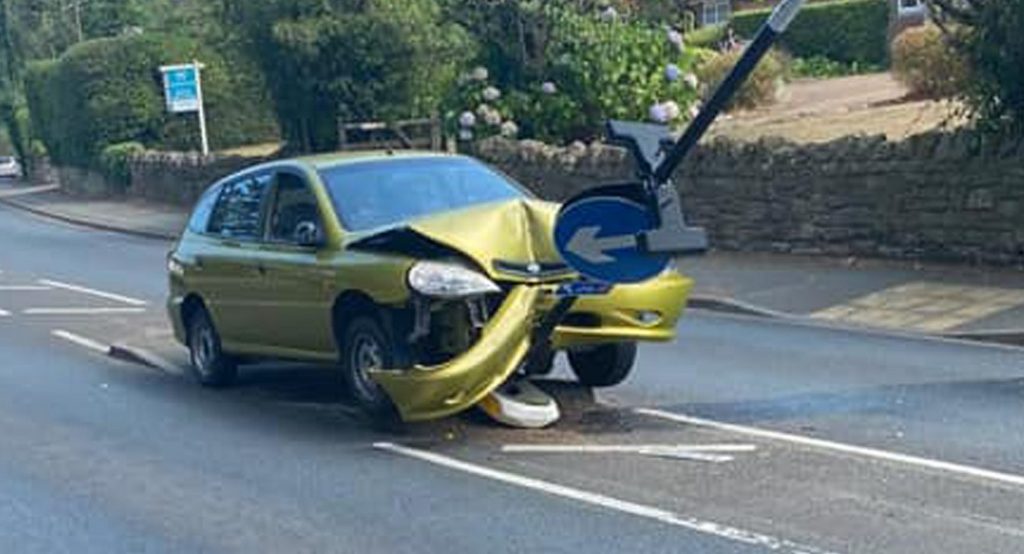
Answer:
(732, 0, 889, 66)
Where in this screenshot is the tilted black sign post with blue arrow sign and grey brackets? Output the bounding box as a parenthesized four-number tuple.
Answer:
(555, 0, 805, 283)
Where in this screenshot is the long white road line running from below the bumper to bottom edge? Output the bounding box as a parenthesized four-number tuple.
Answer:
(374, 442, 828, 554)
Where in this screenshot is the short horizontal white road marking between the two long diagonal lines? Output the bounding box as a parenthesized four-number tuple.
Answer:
(502, 444, 757, 463)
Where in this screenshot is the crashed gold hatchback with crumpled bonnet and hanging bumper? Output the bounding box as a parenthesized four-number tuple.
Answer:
(168, 153, 692, 421)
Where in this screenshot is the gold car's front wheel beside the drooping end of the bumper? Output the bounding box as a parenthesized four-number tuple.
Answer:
(340, 315, 398, 426)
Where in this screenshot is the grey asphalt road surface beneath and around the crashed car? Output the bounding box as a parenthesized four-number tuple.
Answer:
(0, 203, 1024, 553)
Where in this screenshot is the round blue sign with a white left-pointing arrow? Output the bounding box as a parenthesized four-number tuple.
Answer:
(555, 197, 671, 283)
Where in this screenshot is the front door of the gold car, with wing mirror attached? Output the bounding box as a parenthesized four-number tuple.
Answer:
(251, 169, 335, 357)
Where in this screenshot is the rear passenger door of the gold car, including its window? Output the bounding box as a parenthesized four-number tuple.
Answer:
(197, 173, 271, 349)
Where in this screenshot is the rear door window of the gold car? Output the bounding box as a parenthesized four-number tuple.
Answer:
(207, 174, 271, 240)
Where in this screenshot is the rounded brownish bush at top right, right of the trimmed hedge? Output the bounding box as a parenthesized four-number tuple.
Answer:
(892, 25, 969, 98)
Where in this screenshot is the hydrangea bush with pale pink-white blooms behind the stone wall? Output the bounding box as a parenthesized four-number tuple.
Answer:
(447, 3, 714, 143)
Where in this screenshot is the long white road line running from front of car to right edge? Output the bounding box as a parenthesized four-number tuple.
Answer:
(636, 408, 1024, 486)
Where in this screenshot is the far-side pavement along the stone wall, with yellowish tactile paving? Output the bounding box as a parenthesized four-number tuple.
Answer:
(0, 179, 1024, 344)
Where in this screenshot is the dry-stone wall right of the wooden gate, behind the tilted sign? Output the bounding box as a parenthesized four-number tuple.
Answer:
(476, 132, 1024, 264)
